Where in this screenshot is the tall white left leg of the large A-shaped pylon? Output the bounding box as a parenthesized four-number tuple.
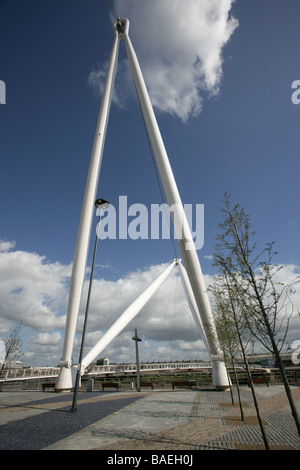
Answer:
(55, 34, 119, 391)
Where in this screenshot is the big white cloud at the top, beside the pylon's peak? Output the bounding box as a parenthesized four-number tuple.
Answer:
(90, 0, 238, 121)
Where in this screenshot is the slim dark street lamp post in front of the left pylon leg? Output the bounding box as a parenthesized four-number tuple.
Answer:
(70, 199, 109, 413)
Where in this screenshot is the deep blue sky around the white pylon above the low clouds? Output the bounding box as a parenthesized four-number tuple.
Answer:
(0, 0, 300, 361)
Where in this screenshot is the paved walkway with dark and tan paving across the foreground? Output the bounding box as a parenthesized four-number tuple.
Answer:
(0, 385, 300, 451)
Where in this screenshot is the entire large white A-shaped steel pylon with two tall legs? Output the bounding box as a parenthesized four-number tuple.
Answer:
(56, 19, 229, 391)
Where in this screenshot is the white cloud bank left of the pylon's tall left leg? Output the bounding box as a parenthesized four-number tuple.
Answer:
(0, 241, 71, 362)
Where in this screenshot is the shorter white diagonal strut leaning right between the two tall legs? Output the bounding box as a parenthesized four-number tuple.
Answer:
(81, 260, 178, 374)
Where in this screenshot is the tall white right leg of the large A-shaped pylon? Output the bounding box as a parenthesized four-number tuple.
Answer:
(122, 19, 229, 388)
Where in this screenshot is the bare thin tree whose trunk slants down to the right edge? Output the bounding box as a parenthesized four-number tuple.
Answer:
(214, 193, 300, 435)
